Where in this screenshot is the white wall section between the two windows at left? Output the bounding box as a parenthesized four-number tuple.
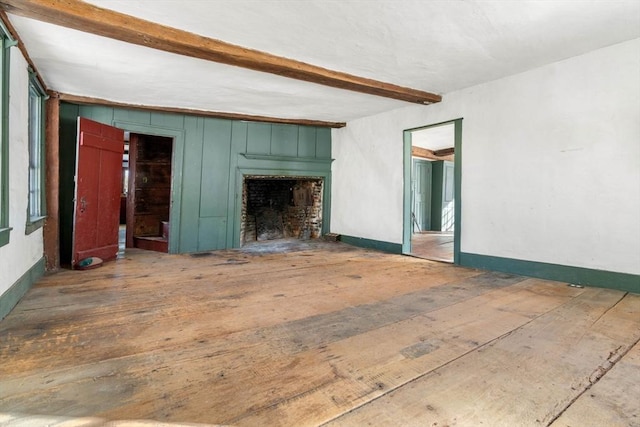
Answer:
(0, 47, 43, 294)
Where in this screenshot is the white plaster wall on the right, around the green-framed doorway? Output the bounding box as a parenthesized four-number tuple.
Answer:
(331, 39, 640, 274)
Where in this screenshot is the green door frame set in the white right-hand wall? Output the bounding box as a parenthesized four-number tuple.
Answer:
(402, 118, 462, 264)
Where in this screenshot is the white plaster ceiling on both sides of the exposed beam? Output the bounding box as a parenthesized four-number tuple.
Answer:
(9, 0, 640, 121)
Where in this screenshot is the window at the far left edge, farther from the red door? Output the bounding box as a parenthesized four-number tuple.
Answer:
(0, 25, 15, 246)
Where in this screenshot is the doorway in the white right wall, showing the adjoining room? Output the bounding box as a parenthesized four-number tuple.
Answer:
(403, 119, 462, 263)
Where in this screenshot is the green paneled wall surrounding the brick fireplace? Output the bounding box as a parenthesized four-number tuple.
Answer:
(60, 103, 331, 256)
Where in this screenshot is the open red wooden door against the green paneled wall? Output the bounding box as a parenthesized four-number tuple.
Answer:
(71, 117, 124, 266)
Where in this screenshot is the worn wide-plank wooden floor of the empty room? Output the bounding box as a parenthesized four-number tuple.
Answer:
(0, 243, 640, 426)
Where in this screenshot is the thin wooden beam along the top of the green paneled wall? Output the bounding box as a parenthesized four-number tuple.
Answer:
(55, 92, 346, 128)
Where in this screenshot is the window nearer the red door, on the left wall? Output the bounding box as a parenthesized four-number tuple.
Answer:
(26, 73, 46, 233)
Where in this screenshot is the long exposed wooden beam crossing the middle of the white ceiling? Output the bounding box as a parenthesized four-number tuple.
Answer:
(0, 0, 442, 104)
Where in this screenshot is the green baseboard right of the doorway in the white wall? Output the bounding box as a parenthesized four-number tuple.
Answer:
(460, 252, 640, 294)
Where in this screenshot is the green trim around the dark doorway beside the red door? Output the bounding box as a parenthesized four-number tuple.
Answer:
(112, 120, 185, 254)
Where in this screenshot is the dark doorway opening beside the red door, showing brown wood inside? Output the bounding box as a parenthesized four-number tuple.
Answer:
(122, 133, 173, 252)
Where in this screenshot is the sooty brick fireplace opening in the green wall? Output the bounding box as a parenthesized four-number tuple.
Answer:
(240, 176, 324, 246)
